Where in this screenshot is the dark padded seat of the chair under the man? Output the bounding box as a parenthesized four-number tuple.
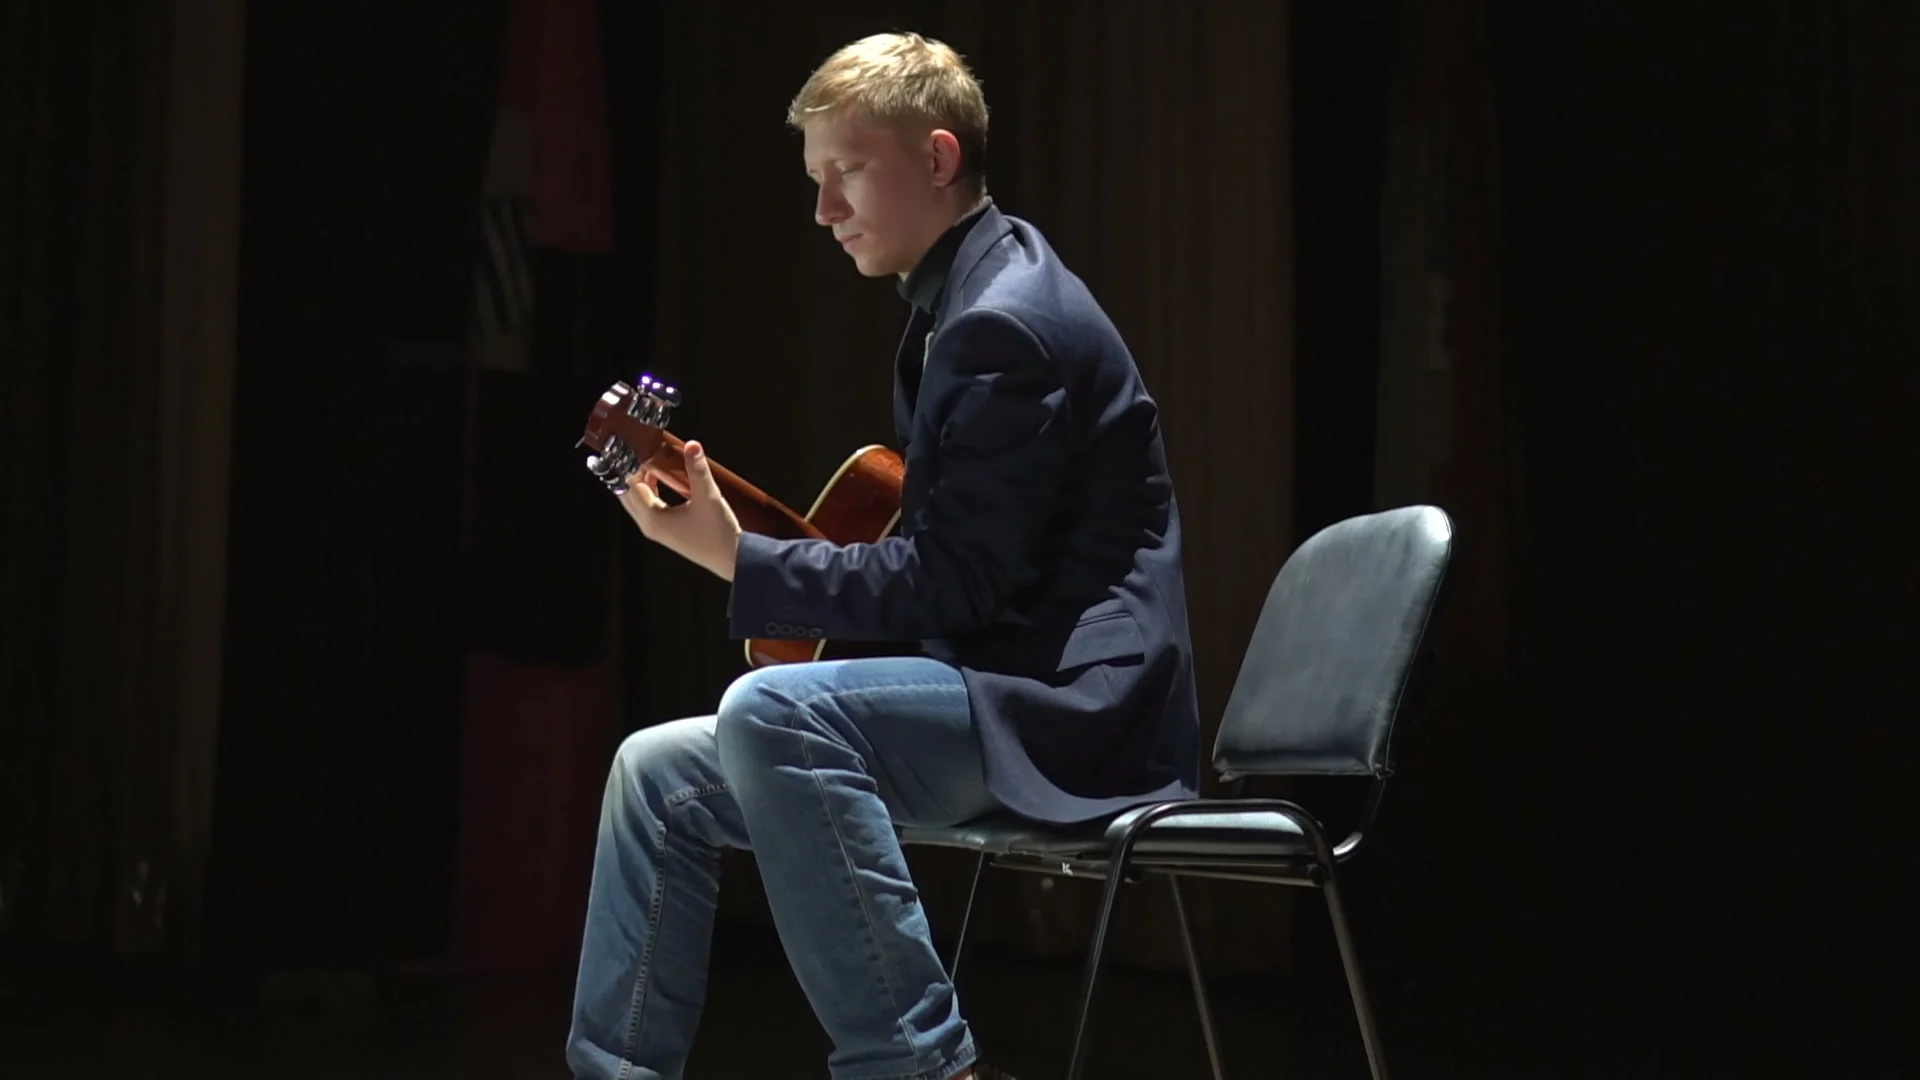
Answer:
(900, 807, 1313, 861)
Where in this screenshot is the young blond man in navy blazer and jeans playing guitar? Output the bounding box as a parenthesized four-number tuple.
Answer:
(566, 35, 1200, 1080)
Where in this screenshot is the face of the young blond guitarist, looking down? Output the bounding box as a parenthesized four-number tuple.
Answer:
(804, 113, 954, 277)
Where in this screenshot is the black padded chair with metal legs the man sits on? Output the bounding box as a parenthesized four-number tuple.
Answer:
(900, 505, 1453, 1080)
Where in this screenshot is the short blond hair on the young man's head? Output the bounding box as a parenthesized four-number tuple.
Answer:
(787, 33, 987, 194)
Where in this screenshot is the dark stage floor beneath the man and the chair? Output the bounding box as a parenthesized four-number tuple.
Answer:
(0, 926, 1908, 1080)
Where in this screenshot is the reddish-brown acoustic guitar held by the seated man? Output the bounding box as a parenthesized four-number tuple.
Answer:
(578, 375, 906, 667)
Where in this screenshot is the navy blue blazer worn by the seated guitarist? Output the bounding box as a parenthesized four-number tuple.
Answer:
(730, 206, 1200, 822)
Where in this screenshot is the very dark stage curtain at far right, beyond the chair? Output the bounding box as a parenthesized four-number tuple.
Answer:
(1377, 0, 1920, 1045)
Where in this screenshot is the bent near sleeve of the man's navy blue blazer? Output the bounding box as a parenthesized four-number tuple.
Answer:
(728, 307, 1073, 642)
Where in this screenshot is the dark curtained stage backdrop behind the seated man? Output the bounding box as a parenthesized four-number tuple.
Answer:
(0, 0, 1920, 1074)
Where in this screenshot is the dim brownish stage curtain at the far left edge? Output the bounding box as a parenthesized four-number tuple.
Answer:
(0, 0, 246, 953)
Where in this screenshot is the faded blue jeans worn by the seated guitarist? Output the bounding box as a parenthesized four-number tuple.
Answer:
(566, 645, 996, 1080)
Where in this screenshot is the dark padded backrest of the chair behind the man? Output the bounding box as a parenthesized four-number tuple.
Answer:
(1213, 505, 1453, 780)
